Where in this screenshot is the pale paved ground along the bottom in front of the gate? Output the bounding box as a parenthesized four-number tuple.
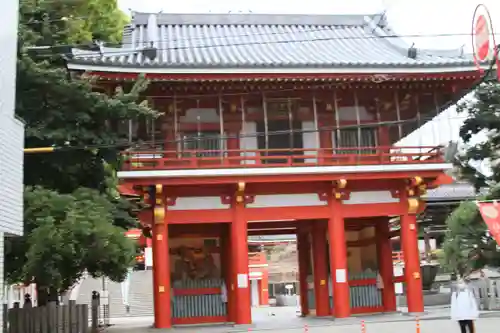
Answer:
(102, 307, 500, 333)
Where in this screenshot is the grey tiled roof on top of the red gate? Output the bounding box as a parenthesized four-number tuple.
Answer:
(69, 13, 473, 68)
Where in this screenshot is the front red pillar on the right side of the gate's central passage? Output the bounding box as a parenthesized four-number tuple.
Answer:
(328, 196, 351, 318)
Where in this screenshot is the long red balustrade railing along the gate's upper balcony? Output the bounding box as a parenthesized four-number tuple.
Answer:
(122, 147, 444, 171)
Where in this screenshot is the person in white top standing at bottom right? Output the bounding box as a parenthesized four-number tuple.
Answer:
(451, 280, 479, 333)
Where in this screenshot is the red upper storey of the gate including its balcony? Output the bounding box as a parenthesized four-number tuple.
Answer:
(116, 89, 456, 178)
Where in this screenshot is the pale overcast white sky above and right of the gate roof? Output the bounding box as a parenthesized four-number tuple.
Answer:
(118, 0, 500, 170)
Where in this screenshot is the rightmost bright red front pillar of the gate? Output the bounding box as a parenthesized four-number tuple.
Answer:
(401, 214, 424, 313)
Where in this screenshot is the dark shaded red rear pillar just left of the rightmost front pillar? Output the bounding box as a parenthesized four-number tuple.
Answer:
(376, 219, 396, 312)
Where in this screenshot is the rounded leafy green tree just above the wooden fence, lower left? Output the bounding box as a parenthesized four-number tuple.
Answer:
(6, 187, 135, 304)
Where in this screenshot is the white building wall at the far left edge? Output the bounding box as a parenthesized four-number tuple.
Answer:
(0, 0, 24, 325)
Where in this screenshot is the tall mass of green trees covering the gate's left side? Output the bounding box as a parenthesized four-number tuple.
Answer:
(5, 0, 150, 305)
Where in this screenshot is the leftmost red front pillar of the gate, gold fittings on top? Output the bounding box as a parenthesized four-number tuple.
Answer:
(153, 185, 172, 328)
